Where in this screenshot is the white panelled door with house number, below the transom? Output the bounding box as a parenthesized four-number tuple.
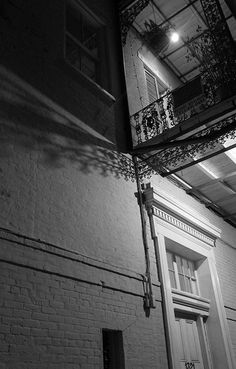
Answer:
(175, 315, 204, 369)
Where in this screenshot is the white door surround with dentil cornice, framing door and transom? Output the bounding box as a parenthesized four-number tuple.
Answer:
(143, 184, 235, 369)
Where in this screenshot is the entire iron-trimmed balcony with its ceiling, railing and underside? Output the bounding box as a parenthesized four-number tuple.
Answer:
(120, 0, 236, 227)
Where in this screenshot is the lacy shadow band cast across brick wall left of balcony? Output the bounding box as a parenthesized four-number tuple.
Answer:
(0, 69, 135, 180)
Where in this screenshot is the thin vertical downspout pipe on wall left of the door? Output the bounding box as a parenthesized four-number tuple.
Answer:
(132, 155, 155, 309)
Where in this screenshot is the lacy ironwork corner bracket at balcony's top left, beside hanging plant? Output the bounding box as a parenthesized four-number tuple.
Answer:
(120, 0, 150, 46)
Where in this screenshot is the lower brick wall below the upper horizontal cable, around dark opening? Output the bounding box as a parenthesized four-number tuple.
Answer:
(0, 232, 167, 369)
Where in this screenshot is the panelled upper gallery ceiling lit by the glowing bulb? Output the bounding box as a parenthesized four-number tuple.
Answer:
(133, 0, 236, 82)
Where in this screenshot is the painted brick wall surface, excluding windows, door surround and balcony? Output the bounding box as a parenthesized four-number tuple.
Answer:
(0, 0, 236, 369)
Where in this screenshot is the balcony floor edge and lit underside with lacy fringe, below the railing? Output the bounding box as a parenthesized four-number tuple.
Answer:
(132, 95, 236, 226)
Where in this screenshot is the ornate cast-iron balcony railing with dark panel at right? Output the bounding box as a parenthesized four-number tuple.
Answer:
(130, 76, 235, 145)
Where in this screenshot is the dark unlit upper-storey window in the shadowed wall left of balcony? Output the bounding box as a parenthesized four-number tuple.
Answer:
(65, 0, 104, 85)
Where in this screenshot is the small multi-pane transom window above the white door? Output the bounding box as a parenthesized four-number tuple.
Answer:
(167, 252, 199, 295)
